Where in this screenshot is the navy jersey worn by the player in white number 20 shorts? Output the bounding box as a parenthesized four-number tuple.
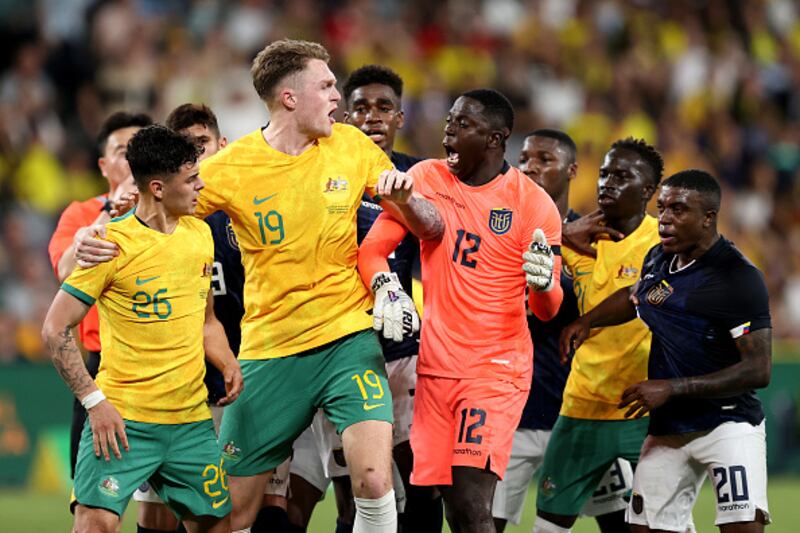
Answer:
(636, 237, 771, 435)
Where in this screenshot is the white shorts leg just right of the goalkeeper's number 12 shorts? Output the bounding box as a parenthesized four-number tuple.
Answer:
(492, 429, 550, 525)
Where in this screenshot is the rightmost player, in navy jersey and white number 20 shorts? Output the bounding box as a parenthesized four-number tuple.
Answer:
(565, 170, 772, 532)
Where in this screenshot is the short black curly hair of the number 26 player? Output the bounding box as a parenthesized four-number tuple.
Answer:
(125, 124, 202, 191)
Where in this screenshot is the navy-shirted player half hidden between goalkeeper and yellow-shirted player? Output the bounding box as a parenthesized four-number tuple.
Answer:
(492, 129, 632, 532)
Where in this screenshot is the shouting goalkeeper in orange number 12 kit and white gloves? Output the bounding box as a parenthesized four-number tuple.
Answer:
(359, 89, 563, 531)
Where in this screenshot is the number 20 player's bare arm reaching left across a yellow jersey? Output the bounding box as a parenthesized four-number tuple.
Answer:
(559, 282, 638, 363)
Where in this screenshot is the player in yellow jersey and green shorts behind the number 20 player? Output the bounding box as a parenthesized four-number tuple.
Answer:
(534, 138, 664, 532)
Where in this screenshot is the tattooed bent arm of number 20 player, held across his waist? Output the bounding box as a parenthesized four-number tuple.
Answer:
(619, 328, 772, 418)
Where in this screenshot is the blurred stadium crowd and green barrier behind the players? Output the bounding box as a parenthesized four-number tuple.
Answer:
(0, 0, 800, 531)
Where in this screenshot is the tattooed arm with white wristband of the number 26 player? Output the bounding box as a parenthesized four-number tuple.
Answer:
(42, 289, 128, 461)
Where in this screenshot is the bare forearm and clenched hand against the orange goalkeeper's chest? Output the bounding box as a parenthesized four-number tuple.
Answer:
(376, 169, 444, 241)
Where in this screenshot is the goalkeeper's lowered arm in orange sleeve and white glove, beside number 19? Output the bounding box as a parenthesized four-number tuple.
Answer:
(358, 212, 419, 342)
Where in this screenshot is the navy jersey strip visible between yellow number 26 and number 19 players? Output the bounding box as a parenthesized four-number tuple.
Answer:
(205, 211, 244, 404)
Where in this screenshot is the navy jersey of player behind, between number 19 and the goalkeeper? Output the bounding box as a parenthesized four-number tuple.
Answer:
(356, 152, 422, 361)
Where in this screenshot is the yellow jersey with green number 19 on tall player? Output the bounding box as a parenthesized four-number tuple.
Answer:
(196, 124, 392, 359)
